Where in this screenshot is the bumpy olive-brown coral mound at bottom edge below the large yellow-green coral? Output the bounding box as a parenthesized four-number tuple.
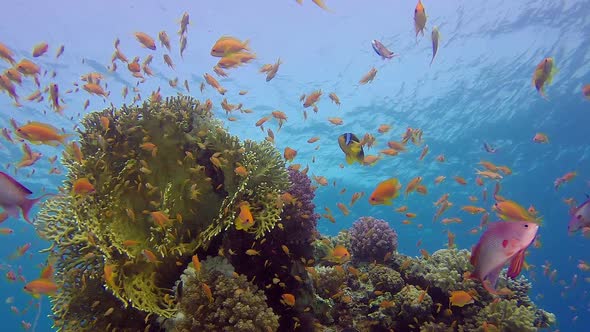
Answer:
(166, 260, 279, 332)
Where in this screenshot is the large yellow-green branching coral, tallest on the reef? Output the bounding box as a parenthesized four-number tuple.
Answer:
(37, 96, 289, 320)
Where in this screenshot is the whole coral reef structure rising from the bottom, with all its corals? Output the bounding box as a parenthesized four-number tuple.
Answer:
(35, 97, 555, 331)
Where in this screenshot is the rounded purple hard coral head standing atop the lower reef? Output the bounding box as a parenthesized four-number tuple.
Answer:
(350, 217, 397, 262)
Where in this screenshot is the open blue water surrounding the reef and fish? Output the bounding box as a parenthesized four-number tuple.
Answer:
(0, 0, 590, 331)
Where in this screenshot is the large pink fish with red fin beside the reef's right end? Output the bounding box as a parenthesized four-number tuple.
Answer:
(470, 221, 539, 294)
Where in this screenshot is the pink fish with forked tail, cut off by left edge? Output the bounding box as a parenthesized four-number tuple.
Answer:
(0, 172, 51, 224)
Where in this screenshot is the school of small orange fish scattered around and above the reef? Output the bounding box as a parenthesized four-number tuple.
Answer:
(0, 0, 590, 329)
